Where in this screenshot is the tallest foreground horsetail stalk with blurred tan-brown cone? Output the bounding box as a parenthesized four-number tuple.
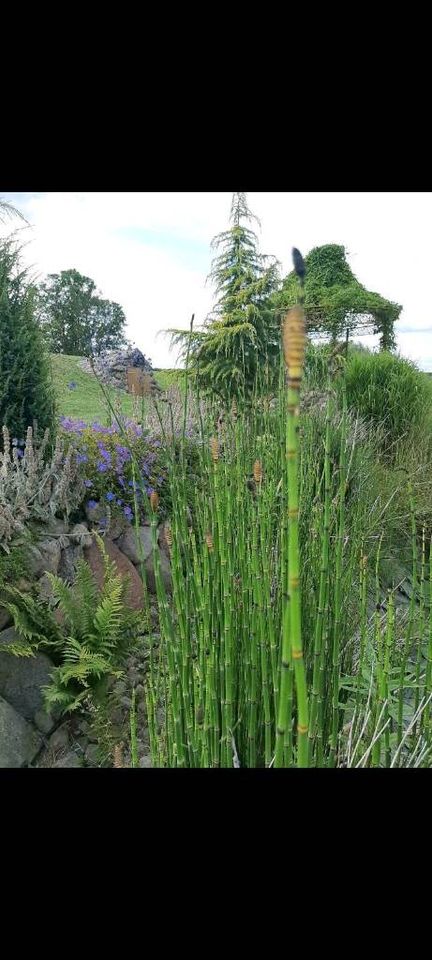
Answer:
(275, 296, 308, 767)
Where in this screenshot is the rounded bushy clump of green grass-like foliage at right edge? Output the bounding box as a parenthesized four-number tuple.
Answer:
(338, 351, 432, 448)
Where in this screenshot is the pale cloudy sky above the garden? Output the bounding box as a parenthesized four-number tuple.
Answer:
(0, 186, 432, 371)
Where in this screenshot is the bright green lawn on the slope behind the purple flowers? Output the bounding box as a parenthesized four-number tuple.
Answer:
(51, 354, 182, 423)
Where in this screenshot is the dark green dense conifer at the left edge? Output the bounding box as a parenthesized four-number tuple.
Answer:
(0, 240, 55, 439)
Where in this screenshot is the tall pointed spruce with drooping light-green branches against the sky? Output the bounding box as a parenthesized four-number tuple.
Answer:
(170, 193, 280, 400)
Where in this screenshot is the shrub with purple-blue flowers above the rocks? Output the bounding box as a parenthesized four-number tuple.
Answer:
(60, 417, 166, 526)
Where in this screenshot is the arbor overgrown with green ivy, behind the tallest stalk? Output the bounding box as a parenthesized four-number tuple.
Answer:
(276, 243, 402, 350)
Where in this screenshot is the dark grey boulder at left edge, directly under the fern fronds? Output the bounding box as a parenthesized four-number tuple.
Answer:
(0, 627, 53, 720)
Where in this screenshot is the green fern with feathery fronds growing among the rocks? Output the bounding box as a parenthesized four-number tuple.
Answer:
(3, 537, 141, 712)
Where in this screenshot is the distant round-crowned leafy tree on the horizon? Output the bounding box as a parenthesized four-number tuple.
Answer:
(37, 270, 126, 356)
